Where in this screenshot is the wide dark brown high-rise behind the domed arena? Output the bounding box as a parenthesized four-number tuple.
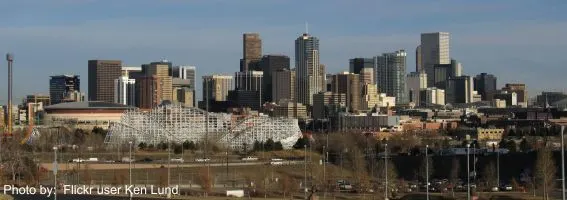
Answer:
(88, 60, 122, 103)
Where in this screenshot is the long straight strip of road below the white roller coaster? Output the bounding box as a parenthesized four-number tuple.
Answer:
(41, 161, 303, 171)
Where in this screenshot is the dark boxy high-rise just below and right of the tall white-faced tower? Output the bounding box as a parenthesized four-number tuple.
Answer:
(445, 76, 474, 104)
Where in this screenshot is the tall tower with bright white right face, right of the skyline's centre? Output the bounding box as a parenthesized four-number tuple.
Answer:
(419, 32, 451, 87)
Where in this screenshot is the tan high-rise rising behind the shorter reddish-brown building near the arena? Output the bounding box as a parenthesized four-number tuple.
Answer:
(142, 60, 173, 103)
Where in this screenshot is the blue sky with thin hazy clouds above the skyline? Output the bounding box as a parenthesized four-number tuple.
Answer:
(0, 0, 567, 104)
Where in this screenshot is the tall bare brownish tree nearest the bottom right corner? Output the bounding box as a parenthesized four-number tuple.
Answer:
(535, 148, 556, 199)
